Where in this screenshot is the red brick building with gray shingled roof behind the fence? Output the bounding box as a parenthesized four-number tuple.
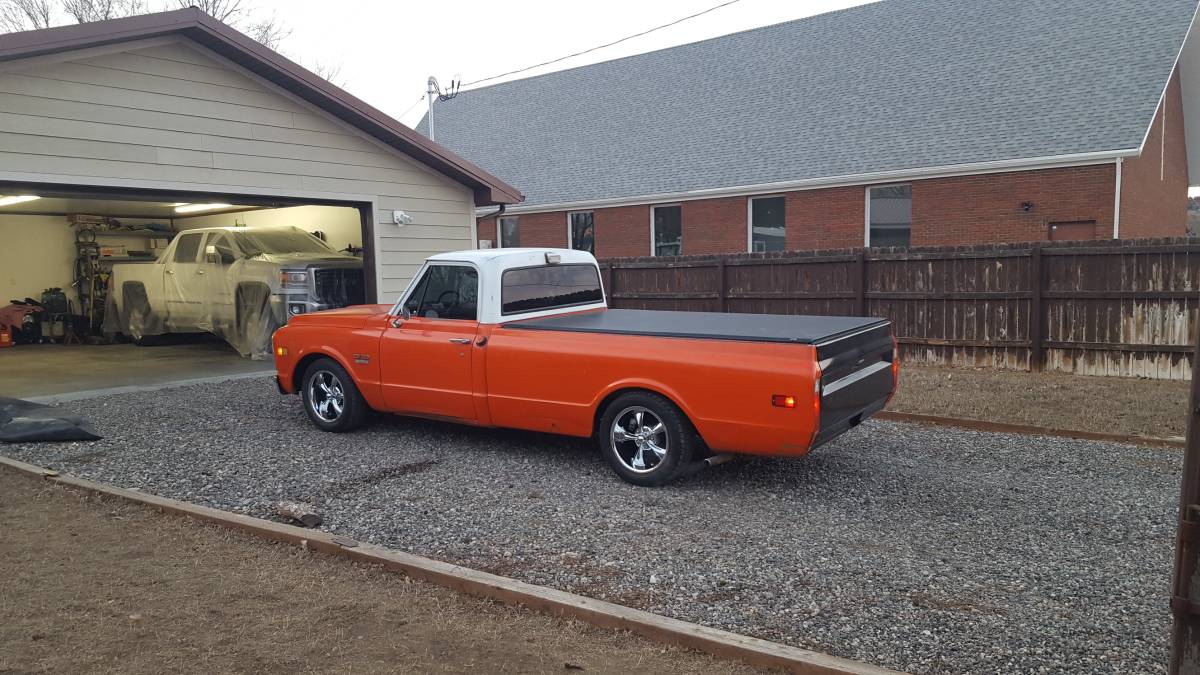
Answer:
(418, 0, 1200, 257)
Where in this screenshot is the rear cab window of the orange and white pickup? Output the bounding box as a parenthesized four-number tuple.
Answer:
(500, 264, 604, 316)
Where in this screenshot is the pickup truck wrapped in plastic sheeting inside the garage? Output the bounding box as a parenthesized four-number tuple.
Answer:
(104, 227, 366, 359)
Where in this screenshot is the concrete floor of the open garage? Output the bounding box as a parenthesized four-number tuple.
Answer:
(0, 336, 272, 399)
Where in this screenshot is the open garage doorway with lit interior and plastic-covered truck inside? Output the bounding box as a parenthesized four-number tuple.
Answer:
(0, 184, 376, 393)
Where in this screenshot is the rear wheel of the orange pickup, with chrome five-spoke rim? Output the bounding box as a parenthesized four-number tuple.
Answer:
(598, 392, 700, 488)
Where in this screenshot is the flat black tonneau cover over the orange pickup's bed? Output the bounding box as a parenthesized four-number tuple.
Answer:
(504, 310, 888, 345)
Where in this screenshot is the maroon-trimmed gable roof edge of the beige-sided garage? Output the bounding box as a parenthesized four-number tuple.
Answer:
(0, 7, 522, 205)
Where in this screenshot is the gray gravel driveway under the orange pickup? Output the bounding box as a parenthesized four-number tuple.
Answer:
(0, 380, 1182, 673)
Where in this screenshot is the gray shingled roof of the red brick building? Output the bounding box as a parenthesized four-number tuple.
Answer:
(418, 0, 1196, 205)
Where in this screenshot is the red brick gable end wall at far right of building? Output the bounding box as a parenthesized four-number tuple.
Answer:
(1121, 71, 1188, 238)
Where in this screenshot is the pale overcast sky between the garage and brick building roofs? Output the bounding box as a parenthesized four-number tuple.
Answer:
(248, 0, 866, 126)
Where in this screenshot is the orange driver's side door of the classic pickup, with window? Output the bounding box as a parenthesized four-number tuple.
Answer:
(379, 263, 479, 422)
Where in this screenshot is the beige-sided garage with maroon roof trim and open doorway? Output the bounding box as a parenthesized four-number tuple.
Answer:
(0, 8, 521, 393)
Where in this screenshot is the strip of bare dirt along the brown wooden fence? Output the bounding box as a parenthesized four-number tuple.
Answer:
(888, 365, 1192, 438)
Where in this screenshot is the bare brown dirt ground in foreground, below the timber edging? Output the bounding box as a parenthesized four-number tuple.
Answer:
(0, 471, 754, 674)
